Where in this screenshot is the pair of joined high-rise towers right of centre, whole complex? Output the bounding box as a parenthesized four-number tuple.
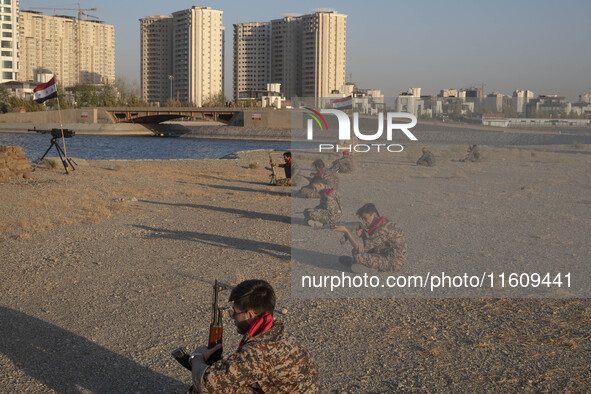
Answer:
(234, 10, 347, 99)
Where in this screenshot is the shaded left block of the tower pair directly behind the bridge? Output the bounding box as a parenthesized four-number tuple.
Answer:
(140, 15, 175, 104)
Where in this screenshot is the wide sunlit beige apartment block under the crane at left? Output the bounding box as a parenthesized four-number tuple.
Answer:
(19, 10, 115, 87)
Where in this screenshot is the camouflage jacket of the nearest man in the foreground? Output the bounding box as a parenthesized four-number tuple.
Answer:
(196, 321, 318, 393)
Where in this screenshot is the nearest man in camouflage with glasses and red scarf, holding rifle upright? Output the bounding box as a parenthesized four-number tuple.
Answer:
(191, 279, 318, 393)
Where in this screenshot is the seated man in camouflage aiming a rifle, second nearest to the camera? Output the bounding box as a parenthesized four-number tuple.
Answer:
(333, 203, 406, 273)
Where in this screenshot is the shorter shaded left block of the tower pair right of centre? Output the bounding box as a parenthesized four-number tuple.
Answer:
(233, 22, 271, 100)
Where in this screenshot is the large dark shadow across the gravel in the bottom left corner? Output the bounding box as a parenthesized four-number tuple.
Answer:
(0, 307, 187, 393)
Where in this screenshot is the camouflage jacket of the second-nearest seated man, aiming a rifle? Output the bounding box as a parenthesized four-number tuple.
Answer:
(359, 219, 406, 260)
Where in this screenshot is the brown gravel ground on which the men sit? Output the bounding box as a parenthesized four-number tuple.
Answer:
(0, 137, 591, 393)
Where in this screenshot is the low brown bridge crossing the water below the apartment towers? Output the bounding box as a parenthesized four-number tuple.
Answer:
(104, 107, 243, 125)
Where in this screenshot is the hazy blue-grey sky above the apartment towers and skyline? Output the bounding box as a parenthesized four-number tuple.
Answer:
(20, 0, 591, 101)
